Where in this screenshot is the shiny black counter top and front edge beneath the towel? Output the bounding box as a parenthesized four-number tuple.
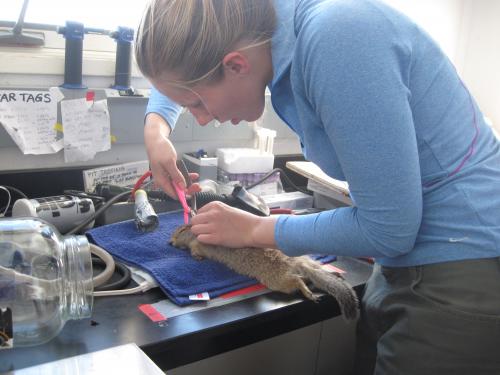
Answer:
(0, 258, 372, 372)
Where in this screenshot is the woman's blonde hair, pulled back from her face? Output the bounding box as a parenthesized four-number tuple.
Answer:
(135, 0, 276, 86)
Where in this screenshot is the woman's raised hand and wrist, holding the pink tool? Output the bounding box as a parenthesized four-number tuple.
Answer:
(144, 113, 200, 199)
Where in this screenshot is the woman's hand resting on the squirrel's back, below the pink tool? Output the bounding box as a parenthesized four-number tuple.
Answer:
(191, 202, 275, 248)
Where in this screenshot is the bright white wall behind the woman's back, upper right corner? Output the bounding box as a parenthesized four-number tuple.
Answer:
(385, 0, 500, 131)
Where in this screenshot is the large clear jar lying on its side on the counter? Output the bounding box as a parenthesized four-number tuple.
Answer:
(0, 218, 93, 350)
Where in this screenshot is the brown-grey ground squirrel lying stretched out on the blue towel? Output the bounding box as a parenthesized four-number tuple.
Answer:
(170, 225, 359, 320)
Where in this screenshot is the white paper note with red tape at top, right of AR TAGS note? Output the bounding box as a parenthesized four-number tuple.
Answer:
(61, 99, 111, 163)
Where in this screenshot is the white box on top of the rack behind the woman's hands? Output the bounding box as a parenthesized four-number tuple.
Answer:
(216, 148, 274, 173)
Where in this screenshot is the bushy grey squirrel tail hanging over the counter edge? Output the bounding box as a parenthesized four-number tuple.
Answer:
(298, 257, 359, 320)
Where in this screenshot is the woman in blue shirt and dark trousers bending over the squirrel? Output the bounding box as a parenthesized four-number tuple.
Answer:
(136, 0, 500, 375)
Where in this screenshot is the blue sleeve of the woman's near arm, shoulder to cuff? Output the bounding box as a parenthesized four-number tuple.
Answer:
(275, 2, 422, 258)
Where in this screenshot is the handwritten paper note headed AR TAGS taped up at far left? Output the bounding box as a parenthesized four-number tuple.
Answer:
(0, 90, 63, 155)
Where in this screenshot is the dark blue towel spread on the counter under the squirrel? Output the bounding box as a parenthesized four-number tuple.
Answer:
(86, 211, 335, 306)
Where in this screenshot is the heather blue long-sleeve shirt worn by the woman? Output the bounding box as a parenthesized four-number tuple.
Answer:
(146, 0, 500, 266)
